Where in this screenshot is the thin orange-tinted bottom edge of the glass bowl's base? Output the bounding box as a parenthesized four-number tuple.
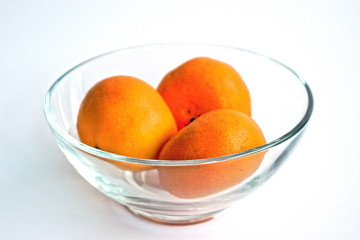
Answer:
(126, 206, 224, 225)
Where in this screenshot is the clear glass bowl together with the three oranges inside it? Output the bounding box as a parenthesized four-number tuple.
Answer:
(44, 44, 313, 224)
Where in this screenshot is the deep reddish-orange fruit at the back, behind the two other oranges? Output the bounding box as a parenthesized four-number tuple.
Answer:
(157, 57, 251, 130)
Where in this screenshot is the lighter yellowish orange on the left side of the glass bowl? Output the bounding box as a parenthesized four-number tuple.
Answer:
(77, 76, 177, 170)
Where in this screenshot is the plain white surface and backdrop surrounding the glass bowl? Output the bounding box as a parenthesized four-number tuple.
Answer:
(0, 0, 360, 240)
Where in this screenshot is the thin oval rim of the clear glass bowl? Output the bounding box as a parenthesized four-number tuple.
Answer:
(43, 43, 314, 166)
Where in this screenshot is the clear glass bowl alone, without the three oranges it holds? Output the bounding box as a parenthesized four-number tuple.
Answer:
(44, 44, 313, 224)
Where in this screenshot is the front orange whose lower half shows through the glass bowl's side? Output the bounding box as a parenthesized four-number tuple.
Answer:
(158, 109, 266, 198)
